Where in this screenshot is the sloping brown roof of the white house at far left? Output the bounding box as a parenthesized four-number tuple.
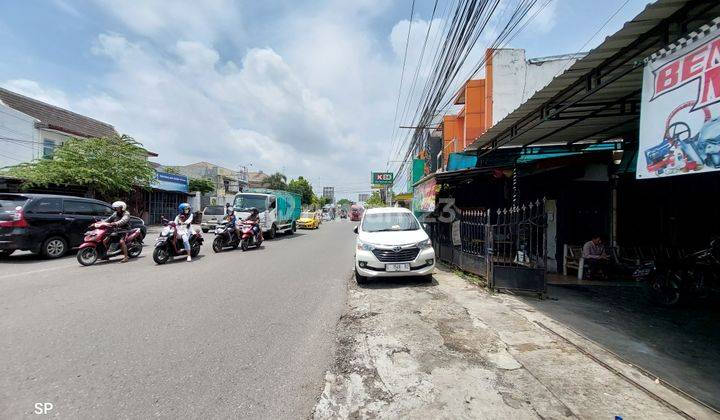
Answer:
(0, 88, 117, 137)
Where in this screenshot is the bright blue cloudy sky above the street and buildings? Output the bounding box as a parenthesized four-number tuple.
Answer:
(0, 0, 647, 199)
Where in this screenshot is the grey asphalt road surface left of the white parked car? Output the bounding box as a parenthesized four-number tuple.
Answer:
(0, 221, 354, 418)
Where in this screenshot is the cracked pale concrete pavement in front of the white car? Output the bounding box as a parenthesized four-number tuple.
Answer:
(315, 270, 718, 419)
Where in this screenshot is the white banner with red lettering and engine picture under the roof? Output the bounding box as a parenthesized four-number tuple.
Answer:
(637, 26, 720, 179)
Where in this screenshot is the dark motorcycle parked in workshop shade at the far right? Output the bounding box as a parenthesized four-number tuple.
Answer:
(644, 239, 720, 306)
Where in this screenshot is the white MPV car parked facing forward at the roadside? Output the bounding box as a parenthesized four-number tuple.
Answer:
(355, 207, 435, 283)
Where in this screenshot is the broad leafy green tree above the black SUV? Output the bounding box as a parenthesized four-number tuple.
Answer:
(7, 135, 155, 199)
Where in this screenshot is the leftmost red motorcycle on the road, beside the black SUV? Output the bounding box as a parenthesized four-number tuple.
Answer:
(77, 222, 142, 266)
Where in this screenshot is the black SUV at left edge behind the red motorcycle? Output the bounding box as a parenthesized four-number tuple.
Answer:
(0, 193, 147, 258)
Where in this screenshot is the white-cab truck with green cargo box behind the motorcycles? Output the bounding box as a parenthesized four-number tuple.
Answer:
(233, 188, 302, 239)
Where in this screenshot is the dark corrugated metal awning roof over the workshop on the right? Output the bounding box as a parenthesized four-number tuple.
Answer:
(466, 0, 720, 154)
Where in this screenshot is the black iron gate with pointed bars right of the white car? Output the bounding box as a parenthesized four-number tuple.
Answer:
(430, 200, 547, 296)
